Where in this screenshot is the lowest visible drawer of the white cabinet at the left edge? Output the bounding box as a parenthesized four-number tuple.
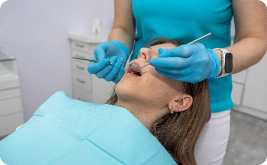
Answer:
(0, 112, 24, 137)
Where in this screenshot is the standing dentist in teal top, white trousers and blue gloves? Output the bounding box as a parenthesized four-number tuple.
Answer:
(88, 0, 267, 165)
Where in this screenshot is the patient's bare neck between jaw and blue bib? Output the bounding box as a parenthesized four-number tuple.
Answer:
(115, 99, 169, 130)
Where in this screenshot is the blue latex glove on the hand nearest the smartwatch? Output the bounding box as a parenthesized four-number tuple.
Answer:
(149, 43, 220, 83)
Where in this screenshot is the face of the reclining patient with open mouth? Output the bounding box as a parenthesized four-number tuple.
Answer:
(115, 43, 185, 106)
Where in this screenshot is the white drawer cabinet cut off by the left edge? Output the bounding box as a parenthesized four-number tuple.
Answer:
(0, 50, 24, 137)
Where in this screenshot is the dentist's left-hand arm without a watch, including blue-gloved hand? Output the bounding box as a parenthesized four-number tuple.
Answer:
(88, 0, 135, 83)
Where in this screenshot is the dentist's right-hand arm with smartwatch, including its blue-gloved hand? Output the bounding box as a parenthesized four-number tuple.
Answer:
(152, 0, 267, 83)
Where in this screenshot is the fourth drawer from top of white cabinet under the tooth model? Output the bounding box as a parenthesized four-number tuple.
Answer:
(73, 71, 92, 92)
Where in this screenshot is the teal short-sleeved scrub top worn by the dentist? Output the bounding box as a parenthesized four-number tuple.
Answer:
(131, 0, 234, 113)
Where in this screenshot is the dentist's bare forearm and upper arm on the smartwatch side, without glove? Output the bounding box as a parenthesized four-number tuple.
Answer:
(218, 0, 267, 76)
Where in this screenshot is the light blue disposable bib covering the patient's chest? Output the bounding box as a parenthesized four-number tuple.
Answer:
(0, 92, 176, 165)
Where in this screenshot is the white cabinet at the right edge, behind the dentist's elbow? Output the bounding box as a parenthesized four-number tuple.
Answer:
(232, 53, 267, 120)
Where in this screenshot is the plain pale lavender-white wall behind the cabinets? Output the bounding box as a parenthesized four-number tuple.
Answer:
(0, 0, 114, 121)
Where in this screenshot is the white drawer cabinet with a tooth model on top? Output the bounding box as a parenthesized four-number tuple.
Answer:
(68, 32, 115, 104)
